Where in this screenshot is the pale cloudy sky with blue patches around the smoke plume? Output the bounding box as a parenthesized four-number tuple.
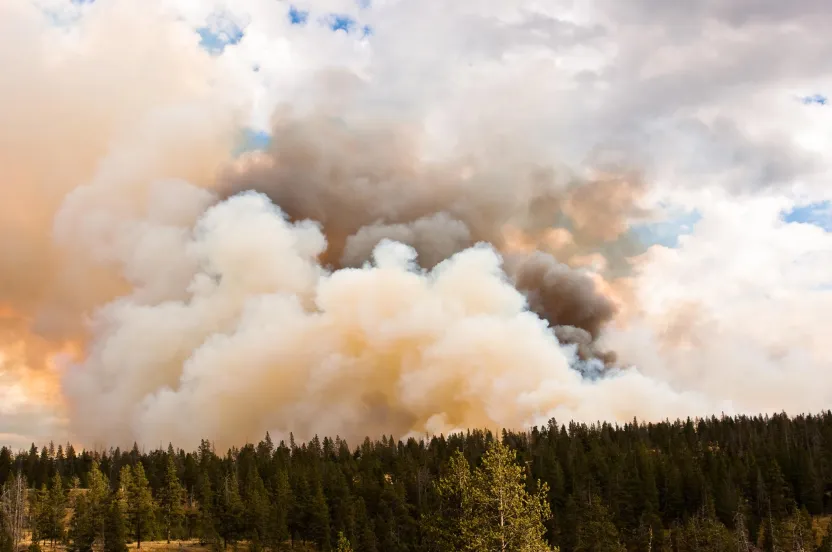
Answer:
(0, 0, 832, 447)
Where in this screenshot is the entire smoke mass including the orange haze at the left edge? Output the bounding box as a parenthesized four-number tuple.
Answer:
(0, 1, 700, 445)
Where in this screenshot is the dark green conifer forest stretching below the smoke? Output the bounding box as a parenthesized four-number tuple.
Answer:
(0, 412, 832, 552)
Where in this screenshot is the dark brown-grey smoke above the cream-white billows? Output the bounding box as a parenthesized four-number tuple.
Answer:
(216, 102, 642, 354)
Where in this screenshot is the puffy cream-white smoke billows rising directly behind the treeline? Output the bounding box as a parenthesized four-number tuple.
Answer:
(58, 190, 704, 443)
